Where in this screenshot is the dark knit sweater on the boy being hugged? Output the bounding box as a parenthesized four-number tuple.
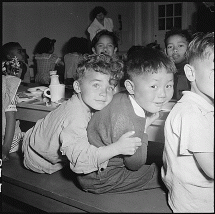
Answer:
(87, 92, 148, 170)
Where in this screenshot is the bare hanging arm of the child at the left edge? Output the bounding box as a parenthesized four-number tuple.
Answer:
(2, 111, 16, 160)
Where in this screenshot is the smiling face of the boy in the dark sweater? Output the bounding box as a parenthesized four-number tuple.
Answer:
(125, 68, 174, 113)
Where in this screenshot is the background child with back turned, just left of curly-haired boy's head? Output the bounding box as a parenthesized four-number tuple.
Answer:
(64, 37, 89, 85)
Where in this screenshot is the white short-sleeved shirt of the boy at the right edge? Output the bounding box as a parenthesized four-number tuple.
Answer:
(161, 91, 214, 213)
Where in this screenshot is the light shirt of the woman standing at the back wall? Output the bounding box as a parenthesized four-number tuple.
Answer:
(87, 18, 113, 41)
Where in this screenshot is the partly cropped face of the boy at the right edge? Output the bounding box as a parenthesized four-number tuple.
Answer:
(193, 51, 214, 102)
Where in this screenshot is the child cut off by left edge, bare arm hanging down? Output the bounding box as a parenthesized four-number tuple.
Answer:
(2, 55, 24, 161)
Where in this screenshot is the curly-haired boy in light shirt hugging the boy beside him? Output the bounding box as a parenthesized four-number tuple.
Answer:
(22, 54, 141, 174)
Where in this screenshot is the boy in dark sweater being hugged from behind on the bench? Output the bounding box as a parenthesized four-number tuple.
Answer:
(78, 48, 176, 193)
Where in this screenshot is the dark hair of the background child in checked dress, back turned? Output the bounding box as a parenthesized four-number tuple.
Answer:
(34, 37, 56, 54)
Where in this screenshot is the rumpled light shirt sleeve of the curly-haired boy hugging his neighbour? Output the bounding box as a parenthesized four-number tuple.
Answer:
(60, 112, 107, 174)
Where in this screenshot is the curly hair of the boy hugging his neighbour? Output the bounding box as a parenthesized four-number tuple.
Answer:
(75, 54, 124, 85)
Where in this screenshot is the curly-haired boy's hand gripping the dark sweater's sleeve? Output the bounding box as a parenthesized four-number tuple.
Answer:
(115, 131, 142, 155)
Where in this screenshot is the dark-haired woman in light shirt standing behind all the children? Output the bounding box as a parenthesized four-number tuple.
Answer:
(87, 6, 114, 41)
